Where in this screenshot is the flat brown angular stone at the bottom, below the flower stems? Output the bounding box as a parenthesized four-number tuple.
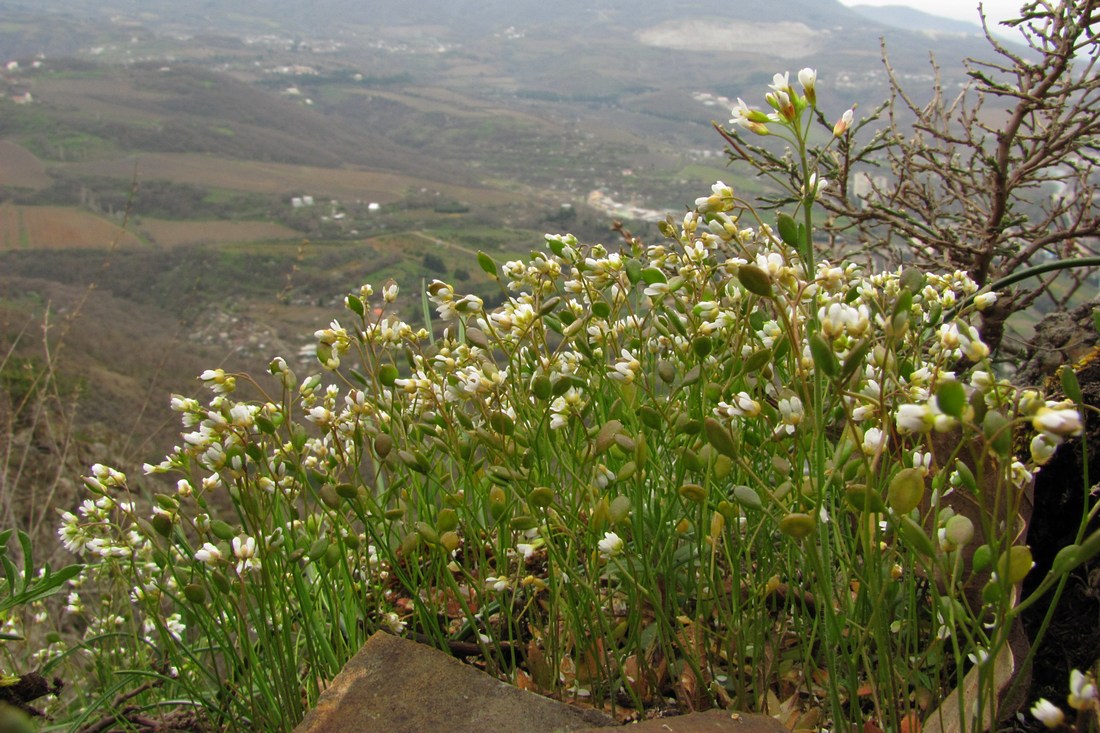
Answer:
(294, 632, 616, 733)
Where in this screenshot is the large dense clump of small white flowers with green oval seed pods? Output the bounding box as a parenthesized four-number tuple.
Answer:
(61, 69, 1100, 731)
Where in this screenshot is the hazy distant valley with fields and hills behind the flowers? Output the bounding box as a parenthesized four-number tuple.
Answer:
(0, 0, 1016, 460)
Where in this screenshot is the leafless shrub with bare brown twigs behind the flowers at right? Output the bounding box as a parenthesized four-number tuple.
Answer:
(719, 0, 1100, 351)
